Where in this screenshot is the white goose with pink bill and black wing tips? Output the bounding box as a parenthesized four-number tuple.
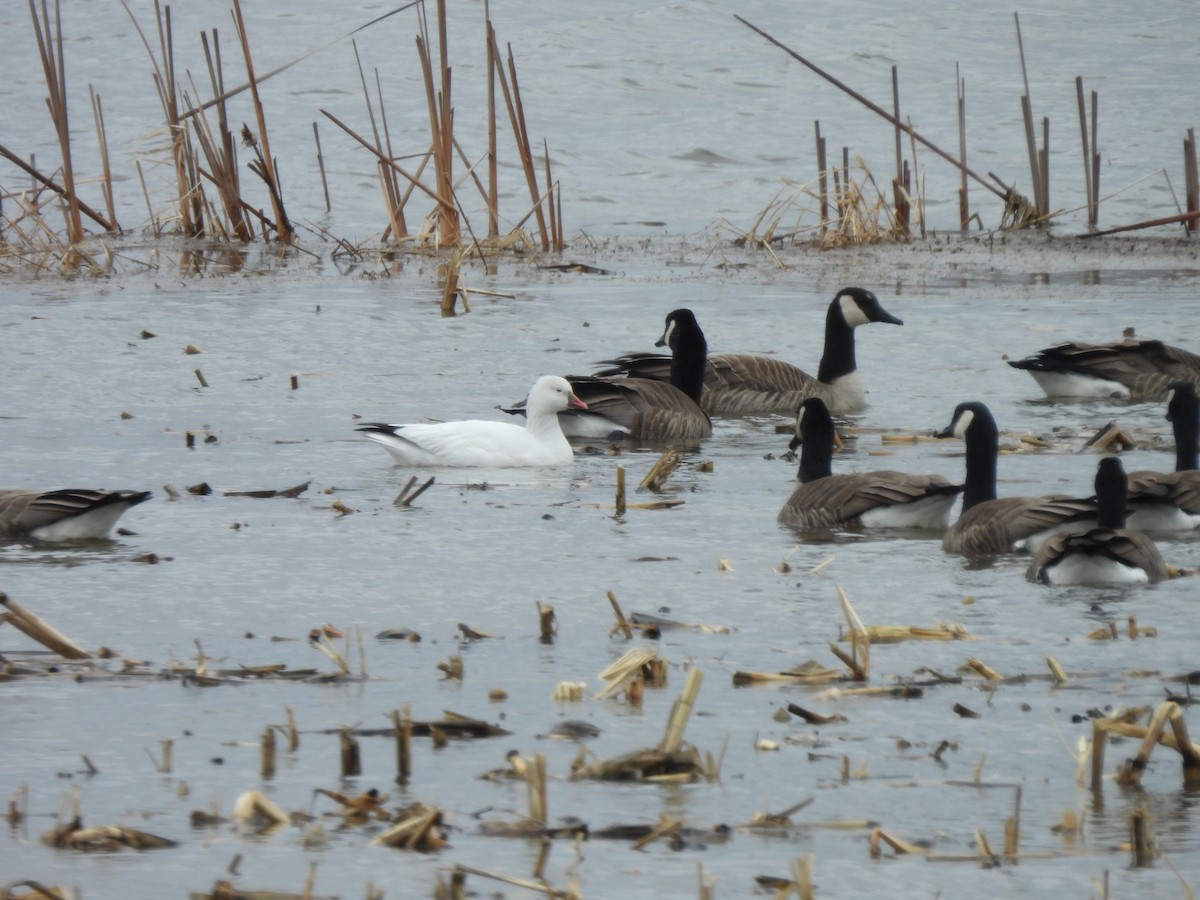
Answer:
(355, 376, 586, 467)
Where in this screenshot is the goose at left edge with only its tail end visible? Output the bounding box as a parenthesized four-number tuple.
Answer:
(0, 488, 150, 541)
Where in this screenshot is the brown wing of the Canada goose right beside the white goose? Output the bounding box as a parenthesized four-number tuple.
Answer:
(569, 376, 713, 444)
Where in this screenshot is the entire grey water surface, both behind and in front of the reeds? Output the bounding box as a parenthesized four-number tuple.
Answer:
(0, 4, 1200, 898)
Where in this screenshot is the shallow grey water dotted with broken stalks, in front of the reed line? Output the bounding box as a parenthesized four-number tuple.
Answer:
(0, 245, 1200, 898)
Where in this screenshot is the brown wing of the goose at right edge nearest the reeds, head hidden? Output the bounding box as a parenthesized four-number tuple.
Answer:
(1009, 338, 1200, 400)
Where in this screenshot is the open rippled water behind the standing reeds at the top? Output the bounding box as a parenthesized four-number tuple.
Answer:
(7, 0, 1200, 242)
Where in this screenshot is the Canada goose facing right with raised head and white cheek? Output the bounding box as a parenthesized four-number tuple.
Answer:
(599, 288, 904, 419)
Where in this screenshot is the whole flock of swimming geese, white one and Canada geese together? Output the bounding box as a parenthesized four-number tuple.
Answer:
(7, 288, 1200, 584)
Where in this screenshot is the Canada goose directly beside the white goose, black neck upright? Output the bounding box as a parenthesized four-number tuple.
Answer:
(505, 310, 713, 445)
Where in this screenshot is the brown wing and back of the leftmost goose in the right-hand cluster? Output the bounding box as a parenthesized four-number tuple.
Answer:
(778, 470, 961, 528)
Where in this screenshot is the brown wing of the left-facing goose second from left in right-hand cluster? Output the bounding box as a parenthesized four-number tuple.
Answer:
(942, 494, 1097, 556)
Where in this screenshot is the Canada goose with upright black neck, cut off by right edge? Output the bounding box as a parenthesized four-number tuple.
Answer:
(1128, 382, 1200, 532)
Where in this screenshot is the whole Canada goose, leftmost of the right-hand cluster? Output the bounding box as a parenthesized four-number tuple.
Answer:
(778, 397, 962, 529)
